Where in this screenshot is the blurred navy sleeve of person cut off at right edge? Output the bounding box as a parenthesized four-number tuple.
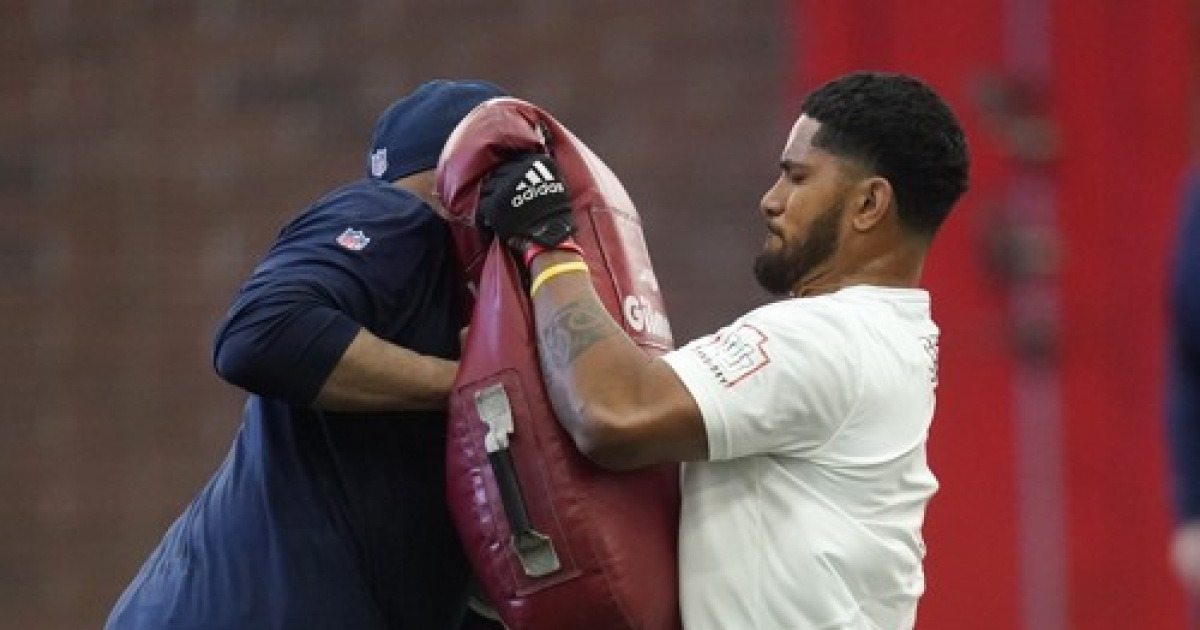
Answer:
(1166, 167, 1200, 521)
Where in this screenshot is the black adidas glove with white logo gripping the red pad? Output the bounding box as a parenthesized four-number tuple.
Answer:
(479, 154, 575, 251)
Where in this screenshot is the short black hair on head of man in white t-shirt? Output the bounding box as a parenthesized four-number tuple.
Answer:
(800, 72, 970, 238)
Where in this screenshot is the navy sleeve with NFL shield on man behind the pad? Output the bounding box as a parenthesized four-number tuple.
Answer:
(214, 184, 444, 404)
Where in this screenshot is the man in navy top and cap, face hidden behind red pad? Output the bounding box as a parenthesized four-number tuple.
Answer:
(107, 80, 503, 630)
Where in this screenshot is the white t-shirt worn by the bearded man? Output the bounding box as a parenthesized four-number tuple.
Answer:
(664, 286, 938, 630)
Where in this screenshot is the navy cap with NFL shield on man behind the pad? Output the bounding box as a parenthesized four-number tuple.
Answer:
(367, 79, 506, 181)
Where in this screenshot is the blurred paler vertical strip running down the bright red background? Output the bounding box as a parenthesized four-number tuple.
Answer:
(1004, 0, 1067, 630)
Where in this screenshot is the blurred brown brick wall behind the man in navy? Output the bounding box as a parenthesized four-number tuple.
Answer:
(0, 0, 791, 630)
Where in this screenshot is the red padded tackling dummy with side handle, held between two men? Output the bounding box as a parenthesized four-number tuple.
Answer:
(437, 98, 680, 630)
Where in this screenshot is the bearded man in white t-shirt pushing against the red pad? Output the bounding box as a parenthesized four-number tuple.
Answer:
(480, 72, 968, 630)
